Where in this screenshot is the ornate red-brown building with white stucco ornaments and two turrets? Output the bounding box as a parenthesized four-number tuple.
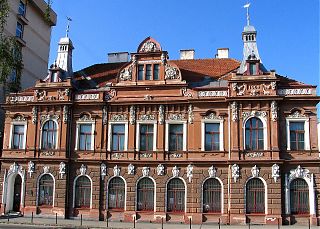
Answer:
(0, 19, 320, 225)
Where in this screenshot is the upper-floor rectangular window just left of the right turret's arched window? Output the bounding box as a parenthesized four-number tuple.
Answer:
(205, 123, 220, 151)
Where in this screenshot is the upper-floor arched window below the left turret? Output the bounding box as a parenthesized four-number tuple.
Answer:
(41, 120, 57, 150)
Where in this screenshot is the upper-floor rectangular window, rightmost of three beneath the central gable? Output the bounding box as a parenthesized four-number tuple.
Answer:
(169, 124, 183, 151)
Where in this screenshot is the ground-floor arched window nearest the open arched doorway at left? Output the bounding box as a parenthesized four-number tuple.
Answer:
(38, 174, 54, 207)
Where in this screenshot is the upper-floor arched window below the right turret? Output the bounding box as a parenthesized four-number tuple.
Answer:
(245, 118, 264, 150)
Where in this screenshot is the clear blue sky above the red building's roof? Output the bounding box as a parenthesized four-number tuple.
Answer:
(49, 0, 320, 85)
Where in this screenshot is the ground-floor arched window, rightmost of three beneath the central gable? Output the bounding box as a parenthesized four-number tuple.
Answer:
(167, 178, 185, 212)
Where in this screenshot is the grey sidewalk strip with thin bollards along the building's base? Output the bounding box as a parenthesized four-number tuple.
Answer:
(0, 217, 319, 229)
